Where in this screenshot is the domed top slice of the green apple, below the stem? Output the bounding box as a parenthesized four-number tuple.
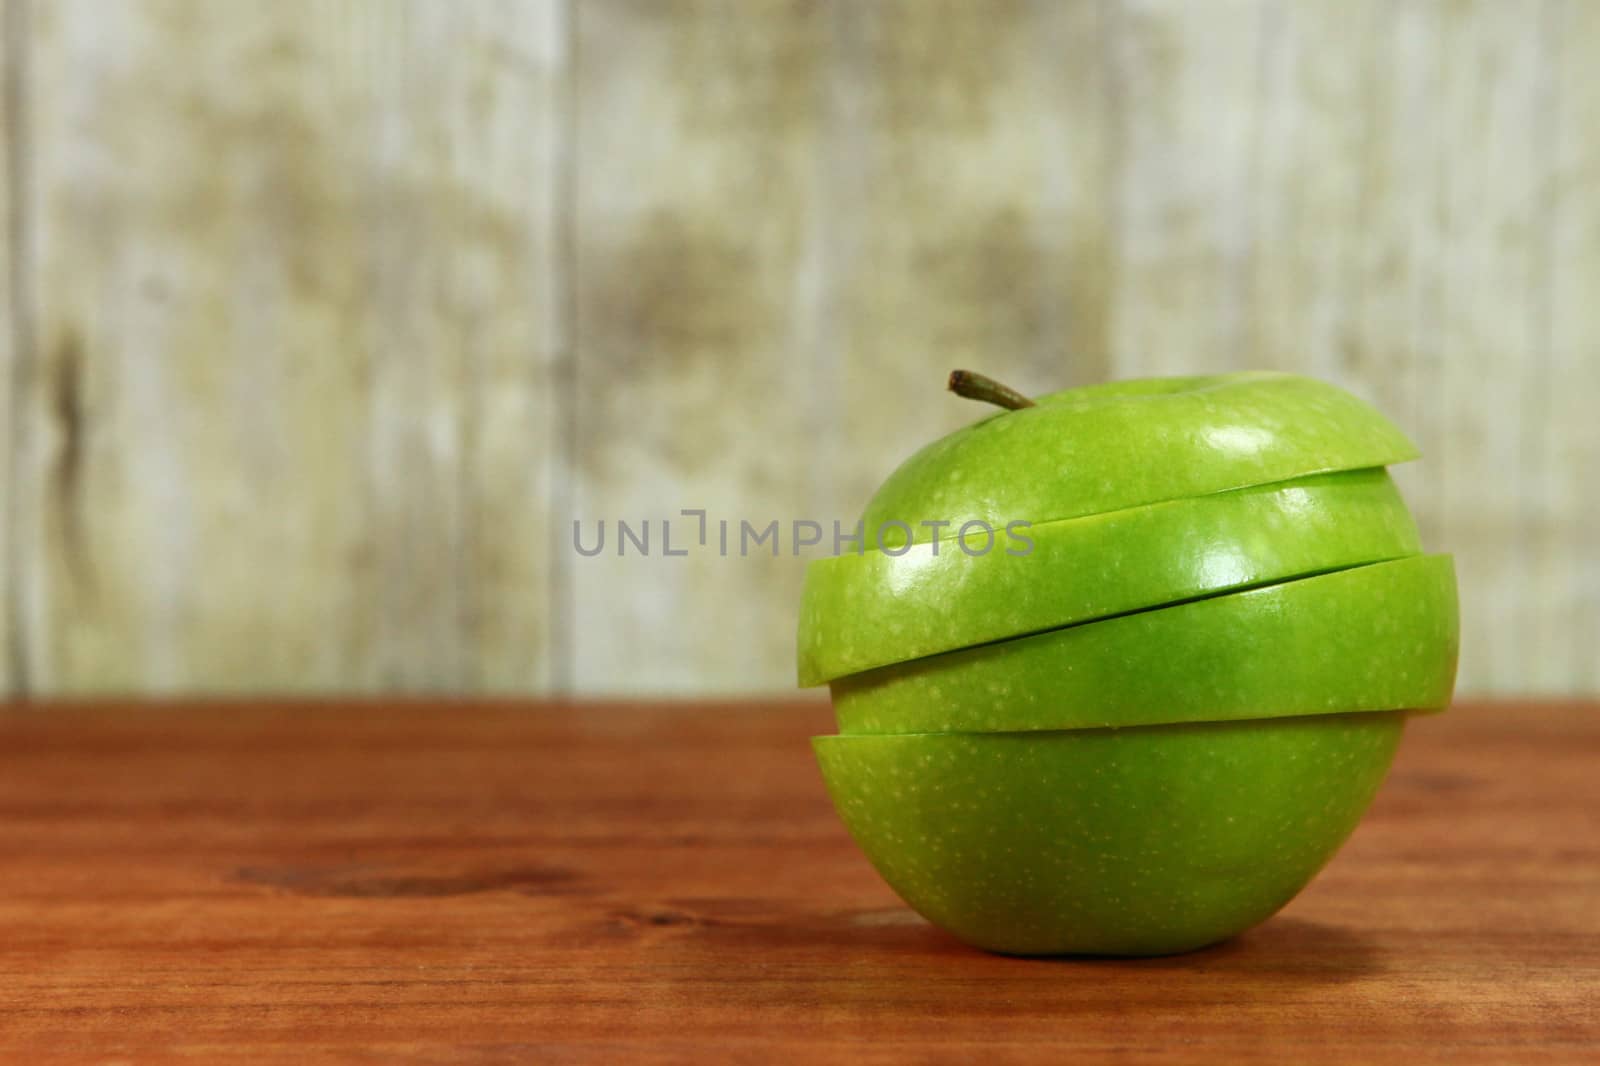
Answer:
(862, 371, 1418, 547)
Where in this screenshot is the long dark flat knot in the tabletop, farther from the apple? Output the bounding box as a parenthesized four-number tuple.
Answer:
(234, 863, 586, 900)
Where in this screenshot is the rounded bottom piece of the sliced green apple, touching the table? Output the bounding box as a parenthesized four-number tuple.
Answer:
(813, 712, 1405, 956)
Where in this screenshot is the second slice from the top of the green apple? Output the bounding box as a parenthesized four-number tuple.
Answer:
(798, 469, 1422, 685)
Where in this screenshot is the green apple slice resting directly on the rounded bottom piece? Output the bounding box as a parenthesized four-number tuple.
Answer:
(832, 555, 1458, 733)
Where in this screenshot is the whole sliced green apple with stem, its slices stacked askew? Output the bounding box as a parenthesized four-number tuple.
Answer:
(800, 371, 1458, 954)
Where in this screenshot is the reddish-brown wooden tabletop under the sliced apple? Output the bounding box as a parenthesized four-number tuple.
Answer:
(0, 703, 1600, 1064)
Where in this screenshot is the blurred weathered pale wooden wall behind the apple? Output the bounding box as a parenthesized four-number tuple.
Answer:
(0, 0, 1600, 695)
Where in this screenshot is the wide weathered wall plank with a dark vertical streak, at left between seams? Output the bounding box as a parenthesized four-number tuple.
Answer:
(10, 0, 554, 691)
